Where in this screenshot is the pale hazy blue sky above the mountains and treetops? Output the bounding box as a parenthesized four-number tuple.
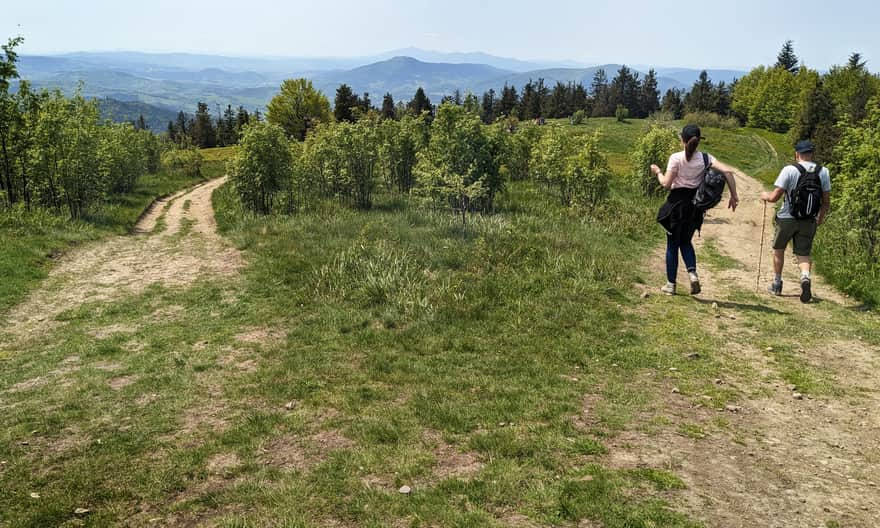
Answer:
(0, 0, 880, 71)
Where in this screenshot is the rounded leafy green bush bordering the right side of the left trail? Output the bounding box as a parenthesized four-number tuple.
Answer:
(229, 123, 293, 214)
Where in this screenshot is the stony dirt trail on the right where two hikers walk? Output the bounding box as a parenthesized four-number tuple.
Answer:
(624, 169, 880, 528)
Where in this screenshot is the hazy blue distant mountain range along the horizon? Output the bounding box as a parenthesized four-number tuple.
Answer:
(10, 48, 746, 129)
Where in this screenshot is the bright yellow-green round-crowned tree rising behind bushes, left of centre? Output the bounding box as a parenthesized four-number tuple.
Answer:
(266, 79, 331, 141)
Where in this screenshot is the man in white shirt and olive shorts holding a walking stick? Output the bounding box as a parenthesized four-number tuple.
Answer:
(761, 141, 831, 303)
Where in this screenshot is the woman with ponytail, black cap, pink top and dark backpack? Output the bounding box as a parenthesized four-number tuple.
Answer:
(651, 125, 739, 295)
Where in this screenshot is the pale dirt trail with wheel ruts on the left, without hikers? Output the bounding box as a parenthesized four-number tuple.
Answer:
(0, 178, 241, 348)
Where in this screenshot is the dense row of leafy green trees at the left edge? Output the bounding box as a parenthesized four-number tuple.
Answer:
(0, 37, 161, 219)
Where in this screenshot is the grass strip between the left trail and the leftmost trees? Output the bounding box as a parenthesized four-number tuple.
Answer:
(0, 149, 227, 313)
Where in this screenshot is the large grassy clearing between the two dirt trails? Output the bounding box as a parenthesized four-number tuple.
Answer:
(0, 120, 880, 528)
